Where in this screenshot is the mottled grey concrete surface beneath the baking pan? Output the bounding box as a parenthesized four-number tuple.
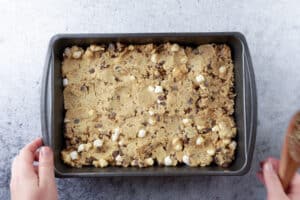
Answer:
(0, 0, 300, 200)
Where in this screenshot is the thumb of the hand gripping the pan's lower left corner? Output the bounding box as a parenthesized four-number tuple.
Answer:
(39, 147, 55, 187)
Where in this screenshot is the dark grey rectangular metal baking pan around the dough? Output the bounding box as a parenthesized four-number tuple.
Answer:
(41, 32, 257, 177)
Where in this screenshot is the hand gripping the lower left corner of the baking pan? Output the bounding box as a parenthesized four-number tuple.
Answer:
(10, 138, 58, 200)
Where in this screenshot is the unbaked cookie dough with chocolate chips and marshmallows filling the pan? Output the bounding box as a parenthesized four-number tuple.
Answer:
(61, 43, 237, 167)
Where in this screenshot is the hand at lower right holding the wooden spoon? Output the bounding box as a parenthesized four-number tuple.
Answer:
(256, 157, 300, 200)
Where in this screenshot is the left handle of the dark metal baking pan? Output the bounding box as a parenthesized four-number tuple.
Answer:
(40, 48, 52, 145)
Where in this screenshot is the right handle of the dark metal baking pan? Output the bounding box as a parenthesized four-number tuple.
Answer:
(244, 44, 257, 163)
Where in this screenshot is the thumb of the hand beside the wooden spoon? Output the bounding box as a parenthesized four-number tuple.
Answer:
(263, 162, 286, 200)
